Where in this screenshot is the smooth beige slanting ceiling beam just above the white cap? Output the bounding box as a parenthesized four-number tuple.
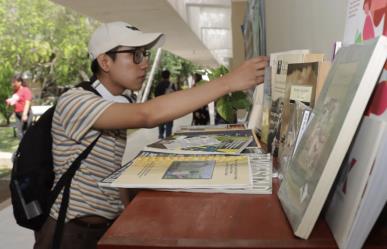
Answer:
(52, 0, 219, 66)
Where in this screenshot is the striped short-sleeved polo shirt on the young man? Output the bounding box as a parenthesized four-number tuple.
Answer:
(50, 88, 126, 220)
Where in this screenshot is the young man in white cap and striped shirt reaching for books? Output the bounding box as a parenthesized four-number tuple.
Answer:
(34, 22, 267, 249)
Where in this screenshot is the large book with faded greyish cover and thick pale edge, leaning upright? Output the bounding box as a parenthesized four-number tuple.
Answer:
(278, 37, 387, 239)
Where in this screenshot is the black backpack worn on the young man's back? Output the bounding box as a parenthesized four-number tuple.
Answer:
(10, 82, 100, 235)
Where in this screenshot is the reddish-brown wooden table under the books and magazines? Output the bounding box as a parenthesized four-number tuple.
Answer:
(98, 182, 387, 249)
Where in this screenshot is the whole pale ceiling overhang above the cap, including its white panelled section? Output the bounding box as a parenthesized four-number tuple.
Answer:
(52, 0, 232, 66)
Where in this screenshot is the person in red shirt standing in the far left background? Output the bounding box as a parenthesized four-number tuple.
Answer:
(5, 74, 32, 140)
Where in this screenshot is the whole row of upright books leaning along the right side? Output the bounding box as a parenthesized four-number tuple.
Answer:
(242, 0, 387, 249)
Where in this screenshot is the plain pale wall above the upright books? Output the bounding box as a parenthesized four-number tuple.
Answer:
(265, 0, 347, 59)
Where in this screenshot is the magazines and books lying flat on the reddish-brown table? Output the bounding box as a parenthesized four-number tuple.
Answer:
(99, 126, 272, 194)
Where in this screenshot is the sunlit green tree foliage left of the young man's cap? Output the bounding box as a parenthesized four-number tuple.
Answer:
(0, 0, 97, 121)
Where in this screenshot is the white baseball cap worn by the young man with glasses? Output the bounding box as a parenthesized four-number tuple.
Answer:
(89, 22, 165, 60)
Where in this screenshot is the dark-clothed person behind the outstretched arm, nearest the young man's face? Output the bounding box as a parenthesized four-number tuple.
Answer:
(155, 70, 176, 139)
